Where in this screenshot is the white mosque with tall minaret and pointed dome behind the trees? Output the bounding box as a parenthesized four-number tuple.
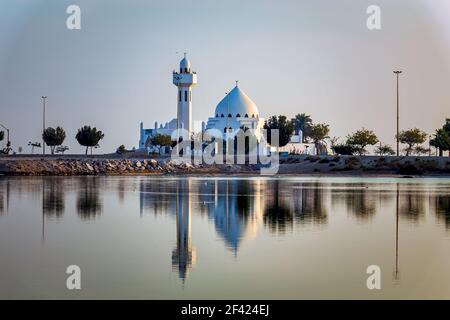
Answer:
(139, 53, 312, 152)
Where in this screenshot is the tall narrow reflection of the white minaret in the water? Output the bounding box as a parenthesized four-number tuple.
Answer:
(172, 179, 196, 283)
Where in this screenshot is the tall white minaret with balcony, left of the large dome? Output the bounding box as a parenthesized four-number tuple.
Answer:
(173, 53, 197, 134)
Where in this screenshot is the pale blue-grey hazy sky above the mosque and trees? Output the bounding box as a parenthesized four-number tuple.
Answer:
(0, 0, 450, 153)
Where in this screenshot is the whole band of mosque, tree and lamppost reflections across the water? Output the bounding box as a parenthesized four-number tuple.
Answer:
(0, 177, 450, 288)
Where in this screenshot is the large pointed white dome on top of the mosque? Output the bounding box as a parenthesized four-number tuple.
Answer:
(215, 86, 259, 118)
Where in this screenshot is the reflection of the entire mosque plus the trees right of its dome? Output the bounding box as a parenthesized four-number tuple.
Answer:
(140, 179, 334, 281)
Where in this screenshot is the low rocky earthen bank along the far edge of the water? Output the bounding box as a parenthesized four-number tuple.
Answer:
(0, 155, 450, 177)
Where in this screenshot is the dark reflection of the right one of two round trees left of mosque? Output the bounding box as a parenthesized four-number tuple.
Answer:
(77, 177, 102, 220)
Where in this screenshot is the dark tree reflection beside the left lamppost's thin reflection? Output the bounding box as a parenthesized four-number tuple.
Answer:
(42, 177, 65, 218)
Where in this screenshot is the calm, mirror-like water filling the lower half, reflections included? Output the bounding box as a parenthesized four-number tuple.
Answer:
(0, 177, 450, 299)
